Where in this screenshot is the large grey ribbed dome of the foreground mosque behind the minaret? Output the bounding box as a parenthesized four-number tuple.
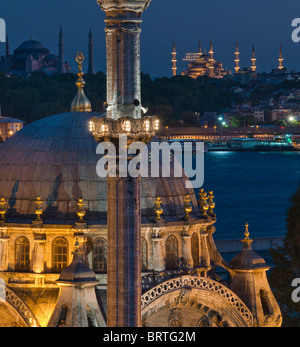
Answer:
(0, 112, 197, 225)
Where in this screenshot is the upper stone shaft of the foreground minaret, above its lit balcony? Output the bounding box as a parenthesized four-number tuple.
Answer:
(105, 18, 141, 119)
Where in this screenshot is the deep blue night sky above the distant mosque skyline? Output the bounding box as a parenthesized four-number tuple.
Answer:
(0, 0, 300, 77)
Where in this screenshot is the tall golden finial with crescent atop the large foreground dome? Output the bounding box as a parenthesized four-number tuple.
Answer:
(71, 52, 92, 112)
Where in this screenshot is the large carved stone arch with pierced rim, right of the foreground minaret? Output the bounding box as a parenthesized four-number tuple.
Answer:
(142, 275, 253, 327)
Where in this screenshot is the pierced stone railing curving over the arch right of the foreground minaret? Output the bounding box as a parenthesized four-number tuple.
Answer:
(142, 276, 253, 326)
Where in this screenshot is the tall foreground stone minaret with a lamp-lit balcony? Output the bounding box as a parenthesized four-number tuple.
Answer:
(90, 0, 159, 327)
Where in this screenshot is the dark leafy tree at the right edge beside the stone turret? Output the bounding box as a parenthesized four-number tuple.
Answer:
(269, 186, 300, 327)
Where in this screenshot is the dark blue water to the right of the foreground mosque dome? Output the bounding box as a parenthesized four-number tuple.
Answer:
(199, 152, 300, 240)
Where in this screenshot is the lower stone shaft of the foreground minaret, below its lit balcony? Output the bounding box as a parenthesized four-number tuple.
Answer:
(107, 177, 142, 327)
